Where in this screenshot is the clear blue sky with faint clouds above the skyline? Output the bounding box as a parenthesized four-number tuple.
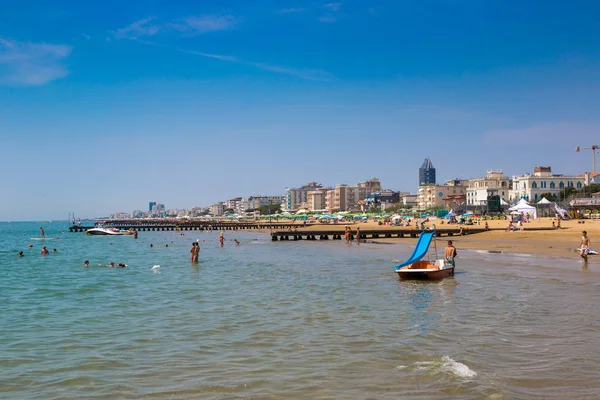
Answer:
(0, 0, 600, 220)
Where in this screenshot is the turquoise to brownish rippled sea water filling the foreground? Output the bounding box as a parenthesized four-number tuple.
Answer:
(0, 222, 600, 399)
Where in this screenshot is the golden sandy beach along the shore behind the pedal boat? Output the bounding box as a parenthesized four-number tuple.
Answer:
(286, 218, 600, 262)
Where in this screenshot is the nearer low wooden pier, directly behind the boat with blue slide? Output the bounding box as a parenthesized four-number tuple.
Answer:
(271, 227, 485, 242)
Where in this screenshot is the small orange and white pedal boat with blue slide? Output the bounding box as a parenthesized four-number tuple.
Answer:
(394, 227, 455, 280)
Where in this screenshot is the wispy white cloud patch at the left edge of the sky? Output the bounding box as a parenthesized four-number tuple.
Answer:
(0, 38, 72, 86)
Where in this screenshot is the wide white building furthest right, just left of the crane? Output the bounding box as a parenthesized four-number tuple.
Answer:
(509, 167, 585, 203)
